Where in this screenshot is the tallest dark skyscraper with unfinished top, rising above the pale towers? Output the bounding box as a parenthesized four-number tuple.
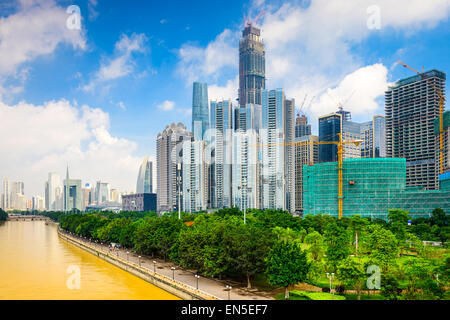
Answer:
(239, 24, 266, 107)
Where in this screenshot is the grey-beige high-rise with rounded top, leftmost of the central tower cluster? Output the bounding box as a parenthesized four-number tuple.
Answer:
(156, 122, 192, 212)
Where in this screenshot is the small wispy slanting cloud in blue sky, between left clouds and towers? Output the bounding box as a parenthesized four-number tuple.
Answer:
(82, 33, 147, 92)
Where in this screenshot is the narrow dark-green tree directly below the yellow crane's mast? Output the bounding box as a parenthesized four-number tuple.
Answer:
(325, 222, 350, 271)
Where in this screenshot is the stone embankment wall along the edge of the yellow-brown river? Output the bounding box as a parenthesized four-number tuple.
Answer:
(57, 227, 220, 300)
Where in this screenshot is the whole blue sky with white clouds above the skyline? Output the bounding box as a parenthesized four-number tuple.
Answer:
(0, 0, 450, 198)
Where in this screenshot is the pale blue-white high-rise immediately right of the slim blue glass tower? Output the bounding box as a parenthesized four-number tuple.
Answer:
(211, 100, 234, 208)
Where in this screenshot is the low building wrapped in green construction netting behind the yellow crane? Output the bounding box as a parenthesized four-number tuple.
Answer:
(303, 158, 450, 219)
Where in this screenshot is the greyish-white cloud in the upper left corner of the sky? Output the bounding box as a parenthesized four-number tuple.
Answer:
(0, 0, 86, 95)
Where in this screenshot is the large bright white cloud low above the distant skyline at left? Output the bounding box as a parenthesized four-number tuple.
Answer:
(0, 100, 141, 197)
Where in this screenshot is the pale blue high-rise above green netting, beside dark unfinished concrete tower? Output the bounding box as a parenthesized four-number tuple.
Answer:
(361, 115, 386, 158)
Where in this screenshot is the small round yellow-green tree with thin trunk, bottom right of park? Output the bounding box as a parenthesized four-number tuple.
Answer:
(337, 257, 366, 300)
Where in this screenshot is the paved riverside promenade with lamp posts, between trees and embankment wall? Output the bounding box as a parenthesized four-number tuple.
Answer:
(63, 230, 274, 300)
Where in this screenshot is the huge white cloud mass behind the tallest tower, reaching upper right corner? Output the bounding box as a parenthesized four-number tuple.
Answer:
(179, 0, 450, 125)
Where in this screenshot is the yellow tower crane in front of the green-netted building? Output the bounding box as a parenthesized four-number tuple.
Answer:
(258, 133, 363, 219)
